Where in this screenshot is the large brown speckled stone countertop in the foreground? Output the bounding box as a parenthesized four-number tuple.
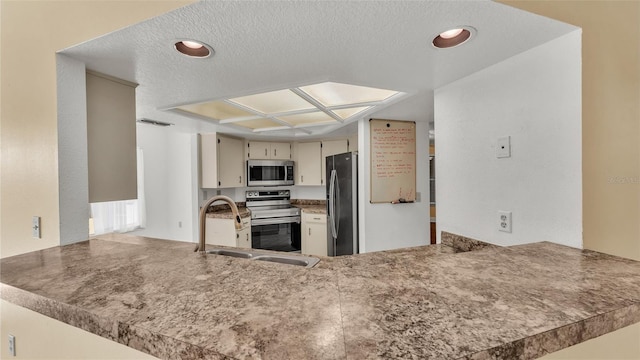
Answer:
(0, 235, 640, 360)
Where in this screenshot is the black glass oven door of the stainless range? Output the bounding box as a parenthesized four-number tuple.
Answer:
(251, 216, 300, 252)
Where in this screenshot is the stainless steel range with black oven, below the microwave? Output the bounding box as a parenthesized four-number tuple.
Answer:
(246, 190, 300, 252)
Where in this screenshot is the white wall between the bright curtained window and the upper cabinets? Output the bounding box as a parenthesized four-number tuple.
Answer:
(132, 123, 198, 241)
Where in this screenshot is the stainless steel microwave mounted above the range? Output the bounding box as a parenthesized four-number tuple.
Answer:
(247, 160, 293, 186)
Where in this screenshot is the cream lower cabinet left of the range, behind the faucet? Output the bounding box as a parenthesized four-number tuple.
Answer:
(204, 217, 251, 248)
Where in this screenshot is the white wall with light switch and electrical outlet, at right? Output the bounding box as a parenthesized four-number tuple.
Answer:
(434, 30, 582, 247)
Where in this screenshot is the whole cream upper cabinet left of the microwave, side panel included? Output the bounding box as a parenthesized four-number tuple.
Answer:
(200, 133, 246, 189)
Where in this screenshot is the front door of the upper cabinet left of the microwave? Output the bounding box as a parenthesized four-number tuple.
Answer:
(218, 136, 244, 187)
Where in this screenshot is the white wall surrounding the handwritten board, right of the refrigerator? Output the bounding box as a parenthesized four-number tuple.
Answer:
(358, 92, 433, 252)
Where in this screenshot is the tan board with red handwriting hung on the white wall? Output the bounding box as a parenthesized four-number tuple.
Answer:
(369, 119, 416, 203)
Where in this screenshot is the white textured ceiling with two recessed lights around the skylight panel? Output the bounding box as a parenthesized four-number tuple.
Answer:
(62, 1, 576, 137)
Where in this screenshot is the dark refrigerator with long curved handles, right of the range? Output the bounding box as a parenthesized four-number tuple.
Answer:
(325, 152, 358, 256)
